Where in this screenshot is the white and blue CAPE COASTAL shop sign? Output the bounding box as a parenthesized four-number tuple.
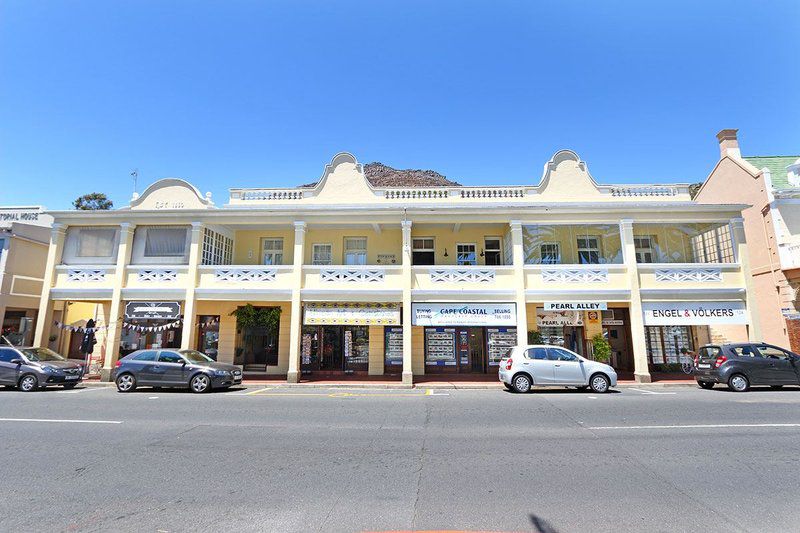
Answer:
(411, 303, 517, 326)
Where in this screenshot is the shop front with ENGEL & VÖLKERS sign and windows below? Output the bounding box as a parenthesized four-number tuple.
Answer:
(642, 301, 747, 372)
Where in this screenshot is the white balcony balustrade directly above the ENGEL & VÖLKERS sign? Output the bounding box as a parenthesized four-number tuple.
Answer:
(638, 263, 745, 298)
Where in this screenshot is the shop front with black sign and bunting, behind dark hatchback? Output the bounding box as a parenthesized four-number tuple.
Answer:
(119, 301, 182, 357)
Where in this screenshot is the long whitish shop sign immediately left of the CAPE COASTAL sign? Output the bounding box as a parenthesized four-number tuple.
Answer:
(303, 302, 400, 326)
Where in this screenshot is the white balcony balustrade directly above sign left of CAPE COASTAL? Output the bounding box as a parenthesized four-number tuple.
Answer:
(302, 265, 403, 301)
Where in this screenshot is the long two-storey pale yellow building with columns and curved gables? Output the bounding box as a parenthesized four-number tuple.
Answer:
(31, 150, 757, 383)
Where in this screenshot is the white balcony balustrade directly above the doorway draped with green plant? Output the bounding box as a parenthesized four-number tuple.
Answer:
(196, 265, 293, 301)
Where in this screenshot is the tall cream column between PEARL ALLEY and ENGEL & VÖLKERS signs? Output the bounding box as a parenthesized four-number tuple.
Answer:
(619, 219, 651, 383)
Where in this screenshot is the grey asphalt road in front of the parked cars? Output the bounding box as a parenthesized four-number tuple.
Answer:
(0, 382, 800, 532)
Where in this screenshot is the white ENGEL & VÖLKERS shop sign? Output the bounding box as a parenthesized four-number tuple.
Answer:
(642, 302, 747, 326)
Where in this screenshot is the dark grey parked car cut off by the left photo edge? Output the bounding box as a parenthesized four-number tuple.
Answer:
(0, 346, 83, 392)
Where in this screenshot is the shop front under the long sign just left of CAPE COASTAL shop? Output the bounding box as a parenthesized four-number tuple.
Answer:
(300, 302, 403, 374)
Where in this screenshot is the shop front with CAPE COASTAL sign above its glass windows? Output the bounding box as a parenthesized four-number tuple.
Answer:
(411, 303, 517, 374)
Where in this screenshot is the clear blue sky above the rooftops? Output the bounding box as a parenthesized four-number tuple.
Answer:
(0, 0, 800, 209)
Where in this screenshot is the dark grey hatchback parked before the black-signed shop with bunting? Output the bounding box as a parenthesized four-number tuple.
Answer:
(113, 350, 242, 393)
